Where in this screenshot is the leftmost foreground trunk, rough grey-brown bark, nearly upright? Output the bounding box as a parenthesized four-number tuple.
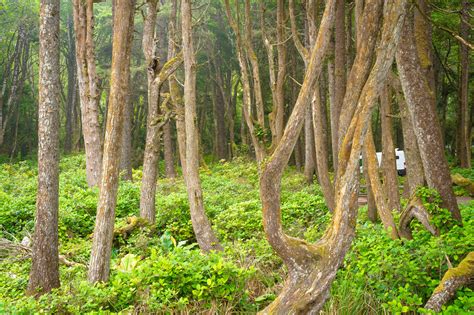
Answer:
(27, 0, 61, 295)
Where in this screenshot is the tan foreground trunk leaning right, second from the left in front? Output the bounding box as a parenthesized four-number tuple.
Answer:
(88, 0, 135, 282)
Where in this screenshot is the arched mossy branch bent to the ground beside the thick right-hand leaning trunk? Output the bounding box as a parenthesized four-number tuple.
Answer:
(398, 196, 439, 240)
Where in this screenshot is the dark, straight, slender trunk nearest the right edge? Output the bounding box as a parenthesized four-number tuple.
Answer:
(456, 0, 472, 168)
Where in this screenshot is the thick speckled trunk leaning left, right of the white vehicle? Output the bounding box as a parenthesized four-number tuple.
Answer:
(397, 12, 461, 222)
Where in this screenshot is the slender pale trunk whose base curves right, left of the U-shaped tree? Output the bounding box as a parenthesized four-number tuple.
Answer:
(181, 0, 222, 252)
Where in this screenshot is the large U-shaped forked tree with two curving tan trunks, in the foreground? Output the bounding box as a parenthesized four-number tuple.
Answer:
(260, 0, 406, 314)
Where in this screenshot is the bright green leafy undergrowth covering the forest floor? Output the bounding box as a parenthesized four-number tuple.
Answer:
(0, 155, 474, 314)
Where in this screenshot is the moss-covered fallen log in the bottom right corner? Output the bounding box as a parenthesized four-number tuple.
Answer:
(425, 252, 474, 312)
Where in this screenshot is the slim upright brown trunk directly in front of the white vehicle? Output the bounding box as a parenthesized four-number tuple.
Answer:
(380, 86, 400, 211)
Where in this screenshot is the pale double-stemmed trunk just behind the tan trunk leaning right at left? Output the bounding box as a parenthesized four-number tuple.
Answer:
(74, 0, 102, 187)
